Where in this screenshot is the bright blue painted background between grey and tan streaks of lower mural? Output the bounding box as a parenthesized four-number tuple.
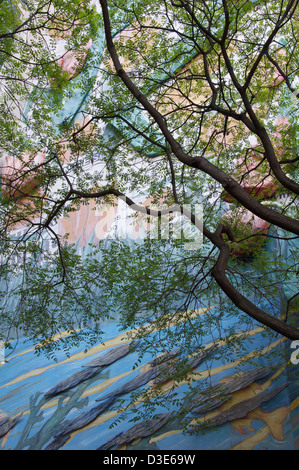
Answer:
(0, 300, 292, 450)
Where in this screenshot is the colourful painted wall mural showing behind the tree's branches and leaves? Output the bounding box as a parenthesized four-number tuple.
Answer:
(0, 3, 299, 451)
